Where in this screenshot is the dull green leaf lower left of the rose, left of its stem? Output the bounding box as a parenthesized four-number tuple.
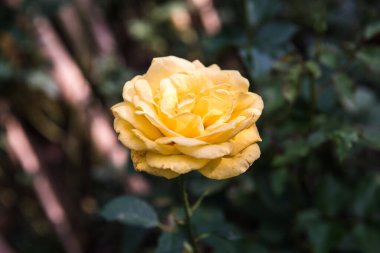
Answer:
(100, 197, 159, 228)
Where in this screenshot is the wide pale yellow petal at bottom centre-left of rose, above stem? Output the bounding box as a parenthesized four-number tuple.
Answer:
(146, 152, 209, 174)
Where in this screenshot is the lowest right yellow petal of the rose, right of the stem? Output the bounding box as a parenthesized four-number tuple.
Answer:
(198, 144, 260, 179)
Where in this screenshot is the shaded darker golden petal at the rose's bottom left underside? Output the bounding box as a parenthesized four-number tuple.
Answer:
(131, 150, 179, 179)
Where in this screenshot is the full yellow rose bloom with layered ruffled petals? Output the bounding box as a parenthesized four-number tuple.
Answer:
(112, 56, 264, 179)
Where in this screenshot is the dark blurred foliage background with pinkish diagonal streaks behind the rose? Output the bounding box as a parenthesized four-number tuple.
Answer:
(0, 0, 380, 253)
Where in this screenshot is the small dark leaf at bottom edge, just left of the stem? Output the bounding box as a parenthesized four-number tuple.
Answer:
(154, 232, 185, 253)
